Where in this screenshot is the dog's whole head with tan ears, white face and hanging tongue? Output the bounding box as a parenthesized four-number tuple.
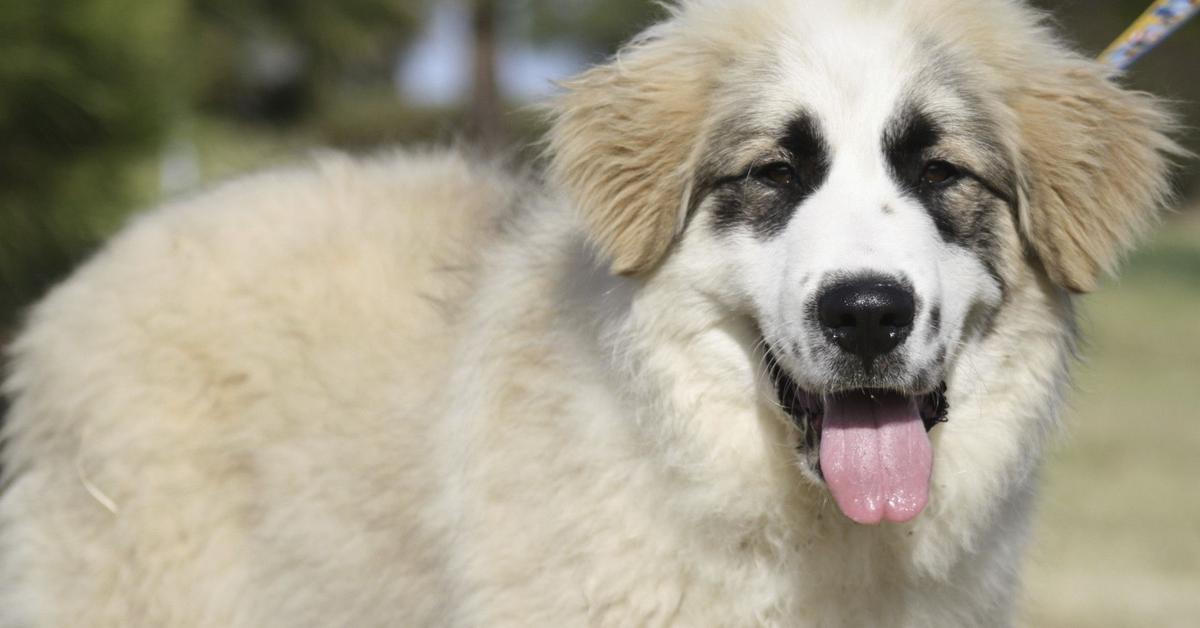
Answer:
(551, 0, 1172, 522)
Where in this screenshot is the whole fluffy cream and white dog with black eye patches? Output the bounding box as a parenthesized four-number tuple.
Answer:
(0, 0, 1176, 627)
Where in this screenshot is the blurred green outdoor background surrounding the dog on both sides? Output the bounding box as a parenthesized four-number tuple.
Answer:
(0, 0, 1200, 627)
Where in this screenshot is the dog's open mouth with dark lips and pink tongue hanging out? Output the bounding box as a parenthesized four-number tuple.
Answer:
(767, 351, 949, 525)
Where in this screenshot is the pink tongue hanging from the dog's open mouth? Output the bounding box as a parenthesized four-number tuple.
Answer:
(821, 393, 934, 525)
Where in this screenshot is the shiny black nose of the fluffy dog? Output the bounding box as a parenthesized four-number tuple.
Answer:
(817, 277, 917, 361)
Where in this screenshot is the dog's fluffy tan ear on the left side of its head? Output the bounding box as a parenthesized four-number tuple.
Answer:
(548, 25, 715, 275)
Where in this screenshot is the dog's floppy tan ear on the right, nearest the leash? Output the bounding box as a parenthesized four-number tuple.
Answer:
(1014, 58, 1182, 292)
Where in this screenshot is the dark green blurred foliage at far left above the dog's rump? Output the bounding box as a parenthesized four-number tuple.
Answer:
(0, 0, 184, 329)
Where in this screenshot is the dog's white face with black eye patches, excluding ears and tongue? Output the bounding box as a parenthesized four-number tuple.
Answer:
(690, 30, 1019, 395)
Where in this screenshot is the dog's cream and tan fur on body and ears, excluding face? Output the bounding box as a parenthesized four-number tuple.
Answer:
(0, 0, 1170, 627)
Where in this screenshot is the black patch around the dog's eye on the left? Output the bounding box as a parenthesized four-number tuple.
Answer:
(713, 113, 832, 239)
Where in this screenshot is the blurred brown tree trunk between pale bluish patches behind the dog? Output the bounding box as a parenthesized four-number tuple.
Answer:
(469, 0, 504, 152)
